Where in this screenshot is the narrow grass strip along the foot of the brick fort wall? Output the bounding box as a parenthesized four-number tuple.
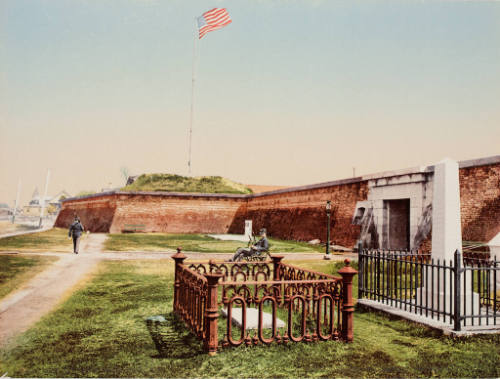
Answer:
(104, 233, 325, 253)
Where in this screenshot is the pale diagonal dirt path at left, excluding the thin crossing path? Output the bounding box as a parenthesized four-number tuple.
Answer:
(0, 234, 107, 346)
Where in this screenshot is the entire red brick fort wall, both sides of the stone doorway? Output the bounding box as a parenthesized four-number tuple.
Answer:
(55, 156, 500, 247)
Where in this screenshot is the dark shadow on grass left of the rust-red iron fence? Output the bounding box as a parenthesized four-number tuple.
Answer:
(146, 313, 204, 359)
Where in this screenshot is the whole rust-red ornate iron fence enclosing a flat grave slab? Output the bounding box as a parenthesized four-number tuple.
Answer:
(172, 248, 357, 354)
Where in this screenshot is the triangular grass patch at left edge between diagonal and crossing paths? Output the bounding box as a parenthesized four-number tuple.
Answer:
(0, 254, 57, 299)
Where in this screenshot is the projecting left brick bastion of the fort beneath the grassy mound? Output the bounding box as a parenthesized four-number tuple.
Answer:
(55, 192, 246, 233)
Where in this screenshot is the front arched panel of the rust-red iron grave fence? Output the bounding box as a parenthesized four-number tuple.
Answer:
(222, 278, 342, 346)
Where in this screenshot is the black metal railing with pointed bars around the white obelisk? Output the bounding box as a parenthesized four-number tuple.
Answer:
(358, 245, 500, 331)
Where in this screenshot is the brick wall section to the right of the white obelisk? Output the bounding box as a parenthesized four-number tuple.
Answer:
(460, 164, 500, 241)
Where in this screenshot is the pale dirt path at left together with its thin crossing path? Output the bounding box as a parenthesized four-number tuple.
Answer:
(0, 234, 357, 347)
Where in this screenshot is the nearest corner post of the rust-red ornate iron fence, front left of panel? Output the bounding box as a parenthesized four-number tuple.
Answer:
(203, 271, 223, 355)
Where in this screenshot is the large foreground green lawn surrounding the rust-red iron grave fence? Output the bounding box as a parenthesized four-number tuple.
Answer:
(0, 260, 500, 377)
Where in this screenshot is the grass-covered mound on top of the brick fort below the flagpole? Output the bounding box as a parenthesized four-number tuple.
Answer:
(122, 174, 252, 194)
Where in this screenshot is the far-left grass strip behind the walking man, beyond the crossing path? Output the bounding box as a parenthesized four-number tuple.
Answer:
(0, 228, 73, 253)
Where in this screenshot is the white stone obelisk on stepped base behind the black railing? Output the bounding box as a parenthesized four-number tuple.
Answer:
(416, 158, 479, 324)
